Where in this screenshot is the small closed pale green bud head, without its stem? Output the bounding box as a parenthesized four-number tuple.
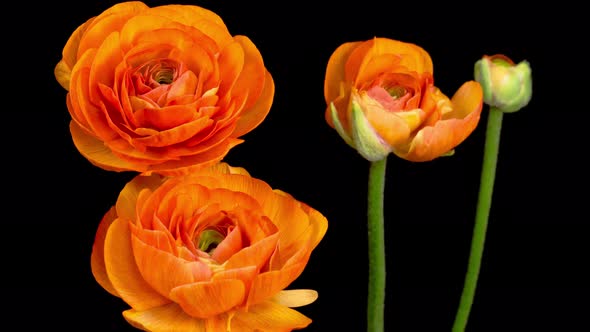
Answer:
(474, 54, 533, 113)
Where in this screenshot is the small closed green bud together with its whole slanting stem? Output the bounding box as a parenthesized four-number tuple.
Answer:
(452, 54, 533, 332)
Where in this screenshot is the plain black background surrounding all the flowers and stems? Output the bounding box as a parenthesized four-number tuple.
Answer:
(5, 0, 590, 332)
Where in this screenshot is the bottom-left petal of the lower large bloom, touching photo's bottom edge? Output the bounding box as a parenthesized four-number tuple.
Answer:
(123, 303, 208, 332)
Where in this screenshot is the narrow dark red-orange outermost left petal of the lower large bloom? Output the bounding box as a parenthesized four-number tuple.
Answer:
(90, 207, 119, 297)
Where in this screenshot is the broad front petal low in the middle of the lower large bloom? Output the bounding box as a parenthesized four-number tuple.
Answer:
(170, 279, 245, 318)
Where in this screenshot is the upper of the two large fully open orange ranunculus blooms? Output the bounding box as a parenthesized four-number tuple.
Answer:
(55, 1, 274, 175)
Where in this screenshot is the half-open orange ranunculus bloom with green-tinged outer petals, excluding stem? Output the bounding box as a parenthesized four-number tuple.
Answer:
(324, 38, 483, 161)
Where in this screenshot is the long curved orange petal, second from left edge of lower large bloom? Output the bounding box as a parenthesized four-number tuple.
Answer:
(104, 218, 170, 310)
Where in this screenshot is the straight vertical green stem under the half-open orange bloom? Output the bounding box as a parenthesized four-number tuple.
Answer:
(367, 157, 387, 332)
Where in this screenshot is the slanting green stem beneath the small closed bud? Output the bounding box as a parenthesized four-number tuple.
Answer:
(453, 107, 503, 332)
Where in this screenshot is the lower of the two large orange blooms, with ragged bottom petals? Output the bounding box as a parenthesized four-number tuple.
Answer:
(91, 163, 327, 332)
